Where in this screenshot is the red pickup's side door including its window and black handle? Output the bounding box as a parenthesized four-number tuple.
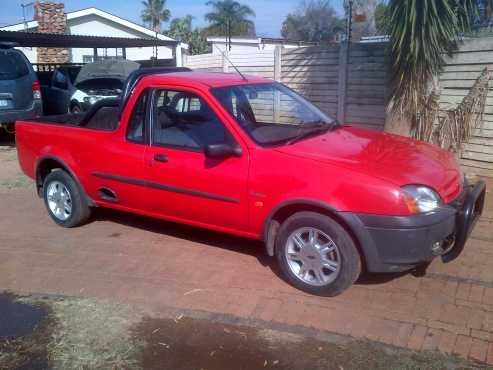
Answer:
(145, 88, 249, 231)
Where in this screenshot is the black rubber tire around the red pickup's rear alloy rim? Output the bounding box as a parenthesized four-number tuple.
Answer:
(43, 169, 91, 228)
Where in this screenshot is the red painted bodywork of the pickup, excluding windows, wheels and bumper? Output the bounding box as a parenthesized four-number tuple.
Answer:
(16, 73, 462, 238)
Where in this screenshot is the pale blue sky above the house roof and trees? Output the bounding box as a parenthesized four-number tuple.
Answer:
(0, 0, 343, 37)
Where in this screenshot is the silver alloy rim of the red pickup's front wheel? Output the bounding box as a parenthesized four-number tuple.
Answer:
(285, 227, 341, 286)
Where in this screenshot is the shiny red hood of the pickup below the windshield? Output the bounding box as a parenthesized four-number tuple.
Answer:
(276, 126, 463, 203)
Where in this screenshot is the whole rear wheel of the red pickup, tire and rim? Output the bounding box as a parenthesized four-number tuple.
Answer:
(43, 169, 91, 227)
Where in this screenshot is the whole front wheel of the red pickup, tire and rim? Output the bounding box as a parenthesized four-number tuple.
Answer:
(276, 212, 361, 297)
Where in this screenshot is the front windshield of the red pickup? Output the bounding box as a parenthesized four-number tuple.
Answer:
(211, 83, 337, 146)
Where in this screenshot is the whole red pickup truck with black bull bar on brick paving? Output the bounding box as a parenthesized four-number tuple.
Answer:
(17, 69, 485, 296)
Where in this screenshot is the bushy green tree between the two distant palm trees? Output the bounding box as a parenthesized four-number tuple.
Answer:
(167, 15, 209, 55)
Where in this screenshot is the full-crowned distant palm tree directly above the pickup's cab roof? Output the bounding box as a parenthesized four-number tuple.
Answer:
(205, 0, 255, 50)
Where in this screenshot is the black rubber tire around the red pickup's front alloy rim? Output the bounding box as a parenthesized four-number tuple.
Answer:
(275, 212, 361, 297)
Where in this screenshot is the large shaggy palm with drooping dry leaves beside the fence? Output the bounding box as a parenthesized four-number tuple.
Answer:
(388, 0, 477, 138)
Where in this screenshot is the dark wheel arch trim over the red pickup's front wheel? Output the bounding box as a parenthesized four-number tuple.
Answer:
(262, 199, 367, 267)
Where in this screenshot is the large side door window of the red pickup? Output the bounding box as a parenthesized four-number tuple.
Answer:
(152, 90, 233, 151)
